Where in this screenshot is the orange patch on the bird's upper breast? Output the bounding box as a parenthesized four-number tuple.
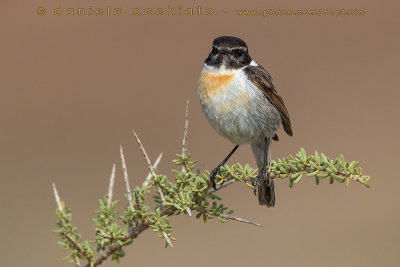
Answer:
(200, 72, 235, 99)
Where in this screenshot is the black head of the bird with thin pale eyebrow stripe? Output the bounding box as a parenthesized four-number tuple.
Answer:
(205, 36, 251, 69)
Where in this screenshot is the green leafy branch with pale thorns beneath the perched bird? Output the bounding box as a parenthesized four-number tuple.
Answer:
(53, 101, 370, 267)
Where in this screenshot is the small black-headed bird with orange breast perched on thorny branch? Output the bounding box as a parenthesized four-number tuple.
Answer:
(197, 36, 293, 207)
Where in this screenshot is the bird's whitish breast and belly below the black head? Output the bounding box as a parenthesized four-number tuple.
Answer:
(198, 66, 281, 145)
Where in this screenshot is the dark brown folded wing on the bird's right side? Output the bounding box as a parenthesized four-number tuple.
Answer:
(244, 65, 293, 136)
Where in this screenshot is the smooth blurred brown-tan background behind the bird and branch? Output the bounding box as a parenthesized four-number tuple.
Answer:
(0, 0, 400, 266)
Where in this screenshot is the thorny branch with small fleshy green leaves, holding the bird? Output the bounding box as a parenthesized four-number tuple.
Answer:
(53, 101, 370, 267)
